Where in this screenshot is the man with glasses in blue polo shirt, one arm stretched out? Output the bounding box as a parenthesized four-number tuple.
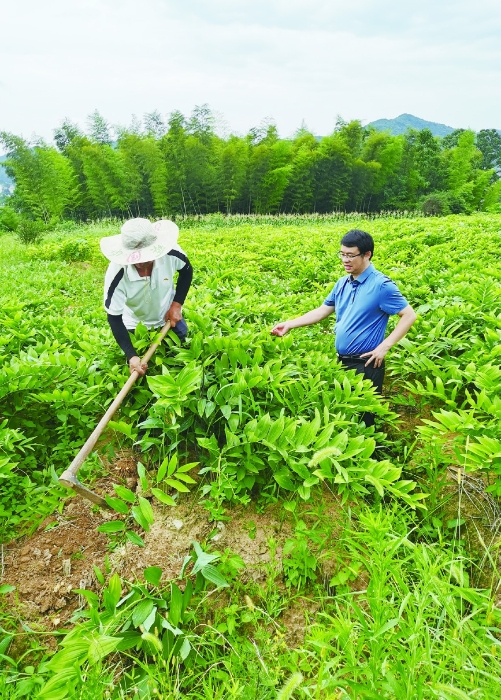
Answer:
(271, 229, 416, 425)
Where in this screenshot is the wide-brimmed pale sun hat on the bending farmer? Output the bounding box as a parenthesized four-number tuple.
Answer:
(99, 219, 179, 265)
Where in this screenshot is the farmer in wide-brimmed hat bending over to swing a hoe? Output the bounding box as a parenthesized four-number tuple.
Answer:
(100, 219, 193, 375)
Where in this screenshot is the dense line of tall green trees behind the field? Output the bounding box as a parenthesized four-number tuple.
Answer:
(0, 105, 501, 222)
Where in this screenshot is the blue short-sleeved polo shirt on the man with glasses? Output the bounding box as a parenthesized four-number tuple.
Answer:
(324, 264, 409, 355)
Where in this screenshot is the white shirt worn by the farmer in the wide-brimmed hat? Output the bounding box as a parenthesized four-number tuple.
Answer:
(104, 245, 191, 330)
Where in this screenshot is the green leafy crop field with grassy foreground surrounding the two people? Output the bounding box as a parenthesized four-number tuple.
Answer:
(0, 214, 501, 700)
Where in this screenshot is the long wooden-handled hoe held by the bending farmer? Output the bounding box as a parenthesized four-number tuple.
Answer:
(59, 321, 170, 508)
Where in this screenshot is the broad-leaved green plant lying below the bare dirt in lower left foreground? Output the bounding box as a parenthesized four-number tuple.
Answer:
(39, 542, 228, 700)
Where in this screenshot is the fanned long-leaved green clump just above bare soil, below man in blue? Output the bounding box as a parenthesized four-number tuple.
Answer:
(198, 410, 425, 507)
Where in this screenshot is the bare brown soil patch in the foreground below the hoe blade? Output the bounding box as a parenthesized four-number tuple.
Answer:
(2, 474, 341, 644)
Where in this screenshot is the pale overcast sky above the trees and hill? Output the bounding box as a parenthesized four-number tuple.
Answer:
(0, 0, 501, 144)
